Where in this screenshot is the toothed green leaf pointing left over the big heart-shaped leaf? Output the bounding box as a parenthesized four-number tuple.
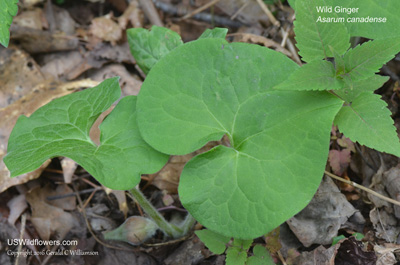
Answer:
(275, 60, 344, 90)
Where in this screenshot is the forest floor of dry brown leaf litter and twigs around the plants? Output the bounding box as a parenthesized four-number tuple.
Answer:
(0, 0, 400, 265)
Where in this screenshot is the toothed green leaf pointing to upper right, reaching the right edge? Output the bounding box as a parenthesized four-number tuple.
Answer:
(344, 38, 400, 82)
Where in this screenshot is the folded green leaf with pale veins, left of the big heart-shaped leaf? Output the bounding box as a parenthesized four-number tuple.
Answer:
(4, 78, 168, 189)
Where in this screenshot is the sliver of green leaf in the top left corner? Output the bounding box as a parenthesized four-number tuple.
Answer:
(0, 0, 18, 47)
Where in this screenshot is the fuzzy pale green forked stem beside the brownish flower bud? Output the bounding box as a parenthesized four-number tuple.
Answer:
(129, 188, 196, 238)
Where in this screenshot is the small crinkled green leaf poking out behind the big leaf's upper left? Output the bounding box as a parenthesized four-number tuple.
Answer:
(126, 26, 182, 74)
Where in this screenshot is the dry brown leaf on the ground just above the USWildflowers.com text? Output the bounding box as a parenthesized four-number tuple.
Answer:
(26, 187, 78, 240)
